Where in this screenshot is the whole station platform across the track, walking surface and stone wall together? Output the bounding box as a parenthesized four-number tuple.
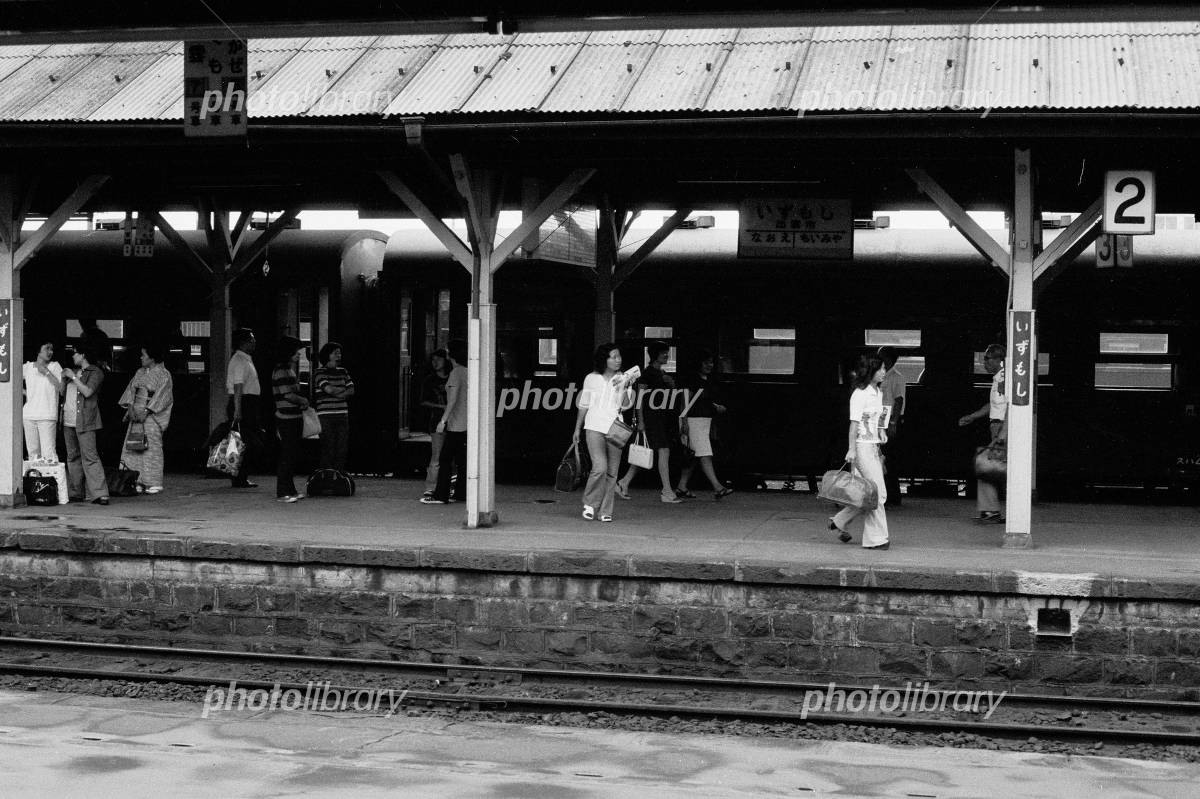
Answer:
(0, 475, 1200, 698)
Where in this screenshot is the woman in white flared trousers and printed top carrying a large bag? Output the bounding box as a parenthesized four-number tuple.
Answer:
(829, 355, 892, 549)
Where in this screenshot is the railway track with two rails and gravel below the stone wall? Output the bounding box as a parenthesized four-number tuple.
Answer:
(0, 637, 1200, 757)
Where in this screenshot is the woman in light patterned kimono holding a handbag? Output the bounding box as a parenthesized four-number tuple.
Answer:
(120, 343, 175, 494)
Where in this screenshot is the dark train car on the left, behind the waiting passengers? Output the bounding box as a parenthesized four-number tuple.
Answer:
(22, 229, 392, 470)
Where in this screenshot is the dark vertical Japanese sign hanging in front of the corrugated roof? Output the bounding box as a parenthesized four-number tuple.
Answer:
(184, 38, 246, 136)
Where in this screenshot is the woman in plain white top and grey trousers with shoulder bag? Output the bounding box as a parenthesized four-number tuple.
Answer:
(571, 343, 632, 522)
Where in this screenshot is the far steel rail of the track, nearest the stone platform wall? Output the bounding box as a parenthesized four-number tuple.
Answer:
(0, 636, 1200, 714)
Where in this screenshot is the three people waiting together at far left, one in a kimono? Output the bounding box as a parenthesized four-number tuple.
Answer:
(22, 338, 174, 505)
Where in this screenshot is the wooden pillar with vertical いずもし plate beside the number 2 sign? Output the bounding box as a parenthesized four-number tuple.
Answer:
(1003, 150, 1040, 548)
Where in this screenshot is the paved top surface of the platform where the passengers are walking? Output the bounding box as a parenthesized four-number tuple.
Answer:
(0, 475, 1200, 590)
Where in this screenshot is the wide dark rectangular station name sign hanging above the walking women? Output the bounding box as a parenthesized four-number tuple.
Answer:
(738, 198, 854, 260)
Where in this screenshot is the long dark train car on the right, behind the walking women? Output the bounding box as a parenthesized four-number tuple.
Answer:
(382, 221, 1200, 495)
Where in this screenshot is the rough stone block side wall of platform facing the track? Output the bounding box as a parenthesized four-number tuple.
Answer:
(0, 533, 1200, 698)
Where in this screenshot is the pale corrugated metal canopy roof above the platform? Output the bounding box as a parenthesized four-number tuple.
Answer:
(0, 22, 1200, 122)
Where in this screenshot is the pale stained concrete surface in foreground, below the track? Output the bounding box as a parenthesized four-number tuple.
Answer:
(0, 691, 1200, 799)
